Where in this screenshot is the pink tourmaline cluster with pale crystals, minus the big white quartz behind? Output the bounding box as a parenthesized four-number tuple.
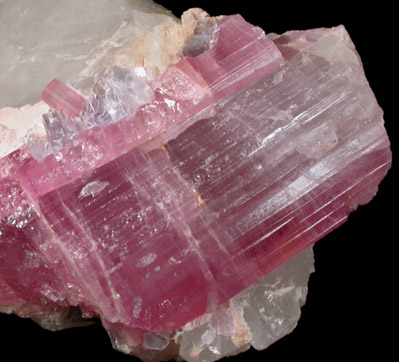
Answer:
(0, 1, 391, 361)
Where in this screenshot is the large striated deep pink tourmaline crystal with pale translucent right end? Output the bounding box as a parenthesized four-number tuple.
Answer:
(0, 11, 391, 345)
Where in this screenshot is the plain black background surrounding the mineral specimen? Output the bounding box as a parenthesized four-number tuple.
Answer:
(0, 0, 399, 362)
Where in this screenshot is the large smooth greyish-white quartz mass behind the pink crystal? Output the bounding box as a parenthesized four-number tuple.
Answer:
(0, 0, 176, 108)
